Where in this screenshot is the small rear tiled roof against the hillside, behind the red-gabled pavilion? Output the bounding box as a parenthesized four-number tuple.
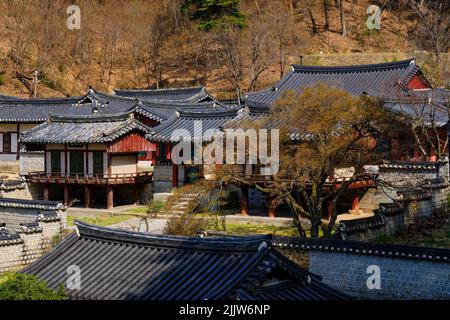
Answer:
(114, 87, 213, 103)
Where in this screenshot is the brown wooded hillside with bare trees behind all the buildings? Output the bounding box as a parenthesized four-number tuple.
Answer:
(0, 0, 450, 98)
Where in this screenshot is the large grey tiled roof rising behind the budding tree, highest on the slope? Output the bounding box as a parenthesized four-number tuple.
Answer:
(245, 59, 426, 107)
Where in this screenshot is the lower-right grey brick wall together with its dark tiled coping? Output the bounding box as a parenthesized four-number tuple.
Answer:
(272, 237, 450, 300)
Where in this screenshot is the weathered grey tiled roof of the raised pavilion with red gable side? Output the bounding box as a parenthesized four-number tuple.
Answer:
(20, 113, 150, 143)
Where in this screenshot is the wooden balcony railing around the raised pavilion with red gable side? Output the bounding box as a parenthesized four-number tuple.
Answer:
(27, 171, 152, 184)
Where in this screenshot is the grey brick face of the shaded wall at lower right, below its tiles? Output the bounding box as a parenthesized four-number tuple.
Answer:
(309, 251, 450, 299)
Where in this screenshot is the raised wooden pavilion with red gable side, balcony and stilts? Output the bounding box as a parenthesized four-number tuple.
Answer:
(21, 112, 155, 208)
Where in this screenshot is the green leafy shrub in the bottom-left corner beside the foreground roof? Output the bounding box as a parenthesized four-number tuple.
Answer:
(0, 273, 67, 300)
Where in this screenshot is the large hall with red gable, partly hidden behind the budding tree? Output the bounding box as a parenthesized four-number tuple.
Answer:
(245, 59, 450, 161)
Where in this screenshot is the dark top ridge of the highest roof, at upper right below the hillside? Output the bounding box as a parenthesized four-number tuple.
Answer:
(291, 58, 415, 73)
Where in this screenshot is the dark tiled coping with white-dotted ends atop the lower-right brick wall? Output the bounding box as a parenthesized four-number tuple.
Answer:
(272, 237, 450, 263)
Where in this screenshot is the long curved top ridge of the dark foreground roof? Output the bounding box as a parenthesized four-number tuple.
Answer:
(75, 221, 271, 252)
